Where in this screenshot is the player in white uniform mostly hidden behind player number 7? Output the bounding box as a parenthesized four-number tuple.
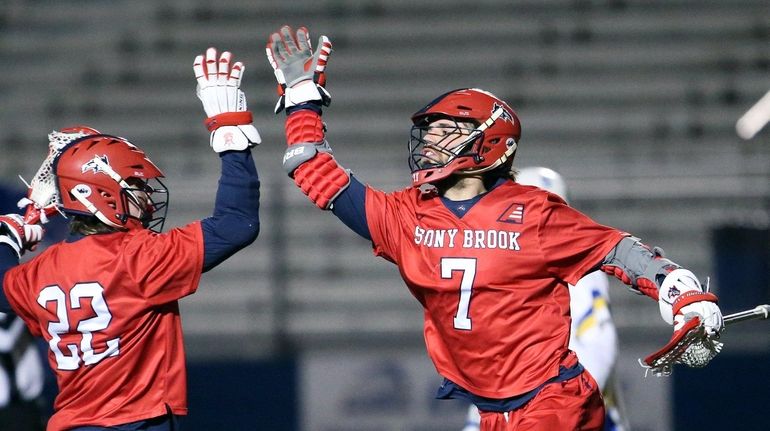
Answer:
(462, 167, 629, 431)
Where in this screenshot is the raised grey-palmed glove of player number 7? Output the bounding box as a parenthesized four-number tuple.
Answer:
(265, 25, 332, 114)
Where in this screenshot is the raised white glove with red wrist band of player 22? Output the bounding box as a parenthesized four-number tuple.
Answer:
(193, 48, 262, 153)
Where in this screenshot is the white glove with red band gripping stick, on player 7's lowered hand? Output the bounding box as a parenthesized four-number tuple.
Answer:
(658, 268, 724, 337)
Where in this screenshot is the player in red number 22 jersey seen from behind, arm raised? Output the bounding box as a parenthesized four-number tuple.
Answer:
(0, 48, 260, 431)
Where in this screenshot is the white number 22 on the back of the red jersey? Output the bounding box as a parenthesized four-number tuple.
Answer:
(37, 283, 120, 370)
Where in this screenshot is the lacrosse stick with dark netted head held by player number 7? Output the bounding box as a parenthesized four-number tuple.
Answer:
(639, 305, 770, 376)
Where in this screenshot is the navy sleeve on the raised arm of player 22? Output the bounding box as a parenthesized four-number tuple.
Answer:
(201, 150, 259, 272)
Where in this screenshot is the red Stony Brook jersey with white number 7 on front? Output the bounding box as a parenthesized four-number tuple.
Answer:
(366, 181, 626, 399)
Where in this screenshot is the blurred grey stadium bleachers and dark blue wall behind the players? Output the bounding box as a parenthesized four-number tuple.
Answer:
(0, 0, 770, 431)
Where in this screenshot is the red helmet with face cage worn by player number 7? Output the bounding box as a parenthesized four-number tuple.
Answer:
(409, 88, 521, 186)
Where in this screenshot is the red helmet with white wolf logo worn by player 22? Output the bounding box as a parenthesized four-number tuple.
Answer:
(54, 133, 168, 232)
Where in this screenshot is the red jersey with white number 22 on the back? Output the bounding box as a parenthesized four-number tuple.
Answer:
(3, 222, 203, 431)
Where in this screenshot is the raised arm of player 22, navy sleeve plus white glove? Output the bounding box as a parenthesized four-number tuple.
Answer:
(193, 48, 261, 271)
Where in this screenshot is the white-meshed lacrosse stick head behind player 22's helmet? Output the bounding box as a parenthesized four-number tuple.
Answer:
(18, 126, 99, 224)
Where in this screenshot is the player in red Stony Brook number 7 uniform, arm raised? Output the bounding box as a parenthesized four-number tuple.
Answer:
(266, 26, 723, 431)
